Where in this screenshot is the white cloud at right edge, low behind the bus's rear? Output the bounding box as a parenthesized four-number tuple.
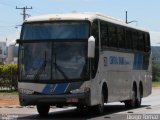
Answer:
(150, 31, 160, 46)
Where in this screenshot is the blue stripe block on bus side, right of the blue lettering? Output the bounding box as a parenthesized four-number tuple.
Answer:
(133, 53, 143, 70)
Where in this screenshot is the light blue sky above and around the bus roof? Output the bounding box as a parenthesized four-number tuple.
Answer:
(0, 0, 160, 46)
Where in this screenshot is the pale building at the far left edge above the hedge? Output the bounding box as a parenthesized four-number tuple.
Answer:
(0, 41, 7, 64)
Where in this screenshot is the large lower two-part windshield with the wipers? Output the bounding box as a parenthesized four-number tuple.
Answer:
(19, 42, 86, 80)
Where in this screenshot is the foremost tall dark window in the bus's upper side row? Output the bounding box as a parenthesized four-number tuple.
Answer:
(100, 21, 108, 49)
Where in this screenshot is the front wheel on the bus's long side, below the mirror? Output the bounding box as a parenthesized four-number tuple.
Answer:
(95, 93, 104, 114)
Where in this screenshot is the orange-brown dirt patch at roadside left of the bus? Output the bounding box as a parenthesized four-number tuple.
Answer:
(0, 94, 19, 106)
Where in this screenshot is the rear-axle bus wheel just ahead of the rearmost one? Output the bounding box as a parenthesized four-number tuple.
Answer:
(124, 87, 136, 108)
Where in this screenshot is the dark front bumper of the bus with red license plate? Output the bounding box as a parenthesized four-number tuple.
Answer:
(19, 92, 90, 106)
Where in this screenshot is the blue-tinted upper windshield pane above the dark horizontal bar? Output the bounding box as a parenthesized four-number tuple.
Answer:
(21, 21, 89, 40)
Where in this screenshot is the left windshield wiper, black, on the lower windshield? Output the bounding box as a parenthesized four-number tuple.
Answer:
(34, 51, 47, 80)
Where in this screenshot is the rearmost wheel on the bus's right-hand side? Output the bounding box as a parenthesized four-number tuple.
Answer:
(136, 84, 143, 107)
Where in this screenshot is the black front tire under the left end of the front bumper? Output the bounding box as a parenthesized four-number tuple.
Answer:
(37, 105, 50, 116)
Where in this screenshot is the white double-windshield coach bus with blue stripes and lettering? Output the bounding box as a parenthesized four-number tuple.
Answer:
(17, 13, 152, 115)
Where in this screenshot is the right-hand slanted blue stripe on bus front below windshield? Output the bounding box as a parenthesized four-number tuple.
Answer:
(54, 83, 69, 94)
